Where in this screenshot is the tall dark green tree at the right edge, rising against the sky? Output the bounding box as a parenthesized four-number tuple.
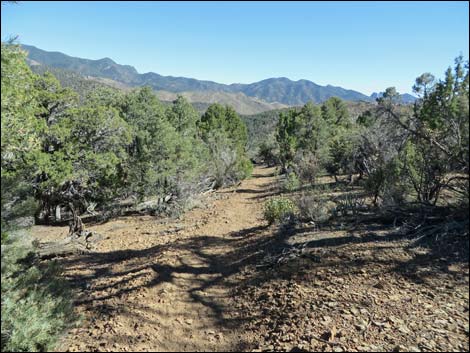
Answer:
(370, 57, 469, 205)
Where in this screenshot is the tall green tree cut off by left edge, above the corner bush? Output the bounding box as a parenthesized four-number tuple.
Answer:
(1, 43, 44, 229)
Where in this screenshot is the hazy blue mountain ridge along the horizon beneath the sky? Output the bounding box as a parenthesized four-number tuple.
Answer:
(22, 45, 414, 105)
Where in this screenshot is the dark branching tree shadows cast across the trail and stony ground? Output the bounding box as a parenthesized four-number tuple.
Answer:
(61, 208, 468, 310)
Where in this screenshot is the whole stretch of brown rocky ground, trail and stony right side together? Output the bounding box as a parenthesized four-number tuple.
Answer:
(34, 167, 469, 351)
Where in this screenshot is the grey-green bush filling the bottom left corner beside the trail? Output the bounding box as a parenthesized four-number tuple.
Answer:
(1, 232, 76, 352)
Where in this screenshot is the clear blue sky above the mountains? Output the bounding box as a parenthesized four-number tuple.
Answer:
(1, 1, 469, 94)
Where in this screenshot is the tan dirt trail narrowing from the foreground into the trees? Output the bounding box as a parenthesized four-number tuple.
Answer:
(34, 167, 275, 351)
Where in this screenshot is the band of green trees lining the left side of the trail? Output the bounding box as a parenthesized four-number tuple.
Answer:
(2, 44, 252, 224)
